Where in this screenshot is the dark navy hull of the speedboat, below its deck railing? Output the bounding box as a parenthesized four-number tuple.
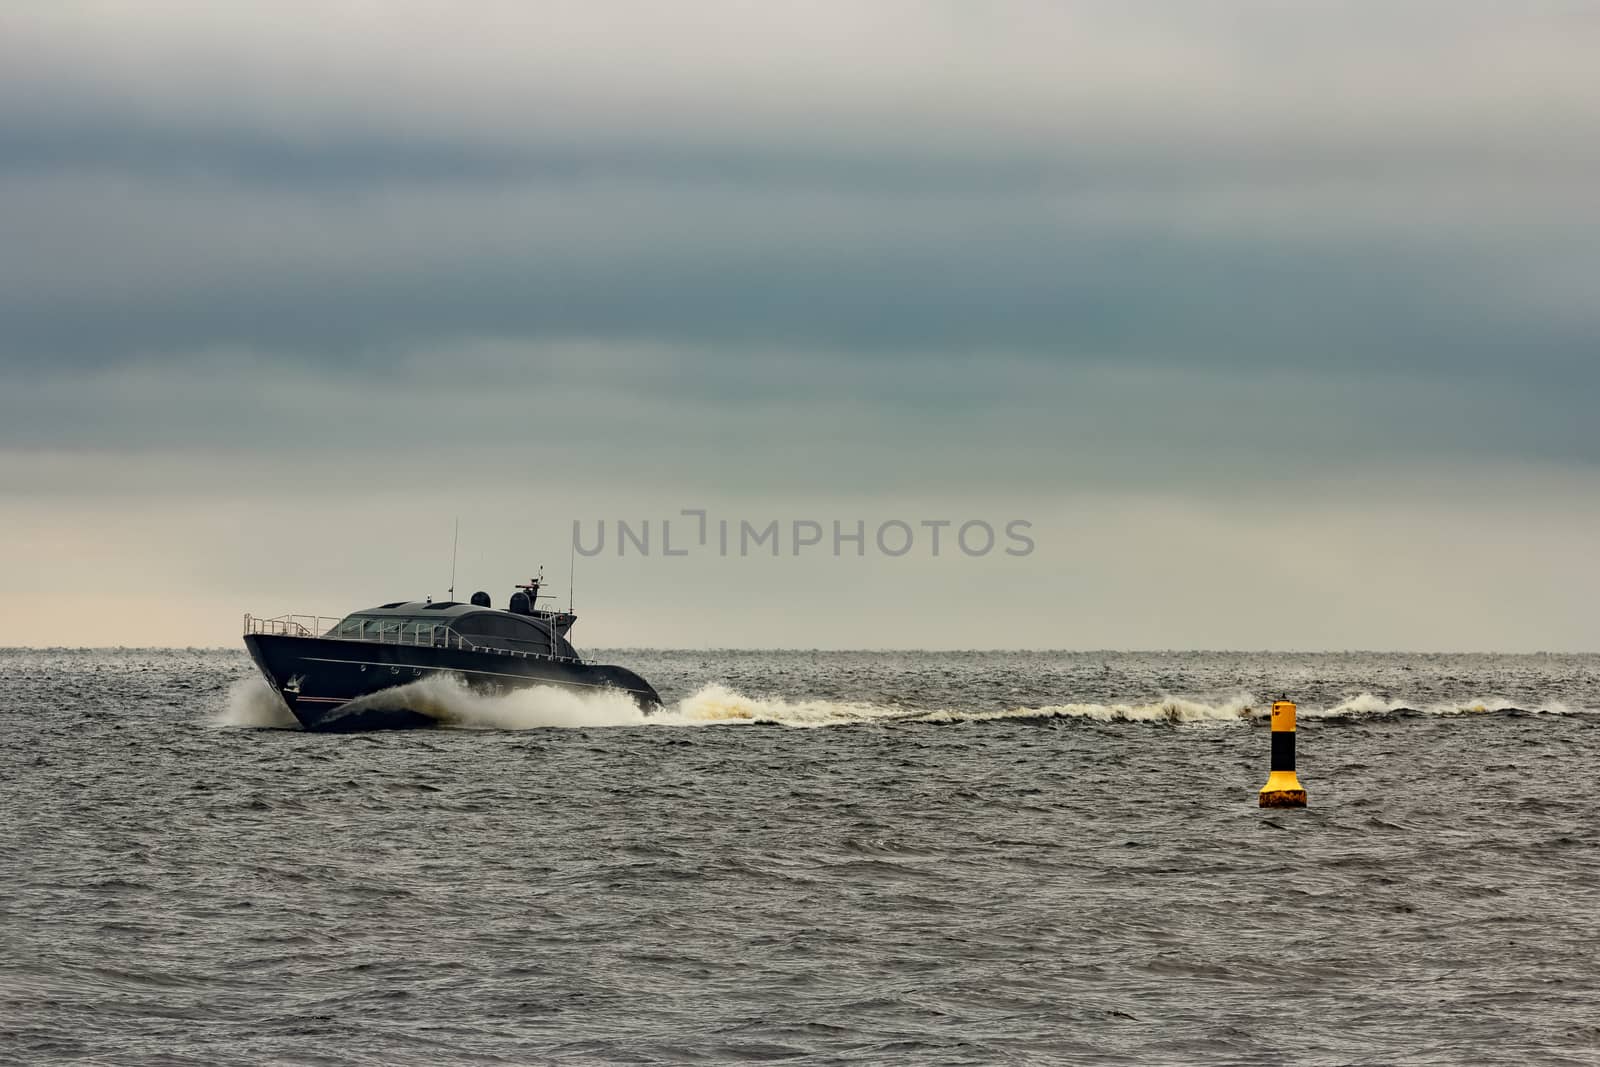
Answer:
(245, 633, 661, 733)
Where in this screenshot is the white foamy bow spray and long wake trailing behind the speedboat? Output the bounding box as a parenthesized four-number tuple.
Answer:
(216, 675, 1584, 729)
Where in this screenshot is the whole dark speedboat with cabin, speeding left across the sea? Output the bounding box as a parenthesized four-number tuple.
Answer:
(245, 579, 661, 731)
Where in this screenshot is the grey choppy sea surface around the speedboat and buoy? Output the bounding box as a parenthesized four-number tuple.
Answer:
(0, 649, 1600, 1065)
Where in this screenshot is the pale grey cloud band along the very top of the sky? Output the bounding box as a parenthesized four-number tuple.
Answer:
(3, 0, 1597, 155)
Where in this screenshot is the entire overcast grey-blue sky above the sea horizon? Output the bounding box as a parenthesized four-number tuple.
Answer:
(0, 0, 1600, 649)
